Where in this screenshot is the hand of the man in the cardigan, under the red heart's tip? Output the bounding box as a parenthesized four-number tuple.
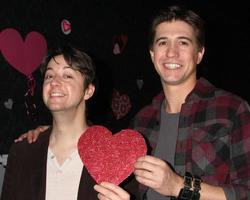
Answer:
(94, 182, 130, 200)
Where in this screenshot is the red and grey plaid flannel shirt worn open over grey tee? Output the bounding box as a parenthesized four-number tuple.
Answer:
(132, 78, 250, 199)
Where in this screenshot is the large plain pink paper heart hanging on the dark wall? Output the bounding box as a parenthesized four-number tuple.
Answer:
(0, 28, 47, 76)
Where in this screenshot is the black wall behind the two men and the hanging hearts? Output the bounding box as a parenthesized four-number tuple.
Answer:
(0, 0, 250, 153)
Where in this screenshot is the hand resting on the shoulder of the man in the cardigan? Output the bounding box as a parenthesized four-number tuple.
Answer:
(14, 126, 49, 143)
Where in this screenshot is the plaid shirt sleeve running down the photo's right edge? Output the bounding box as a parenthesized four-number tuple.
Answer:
(224, 102, 250, 200)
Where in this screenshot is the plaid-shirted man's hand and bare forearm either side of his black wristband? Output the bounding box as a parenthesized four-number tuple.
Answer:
(134, 156, 226, 200)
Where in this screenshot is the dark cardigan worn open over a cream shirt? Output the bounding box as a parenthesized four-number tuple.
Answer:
(1, 129, 139, 200)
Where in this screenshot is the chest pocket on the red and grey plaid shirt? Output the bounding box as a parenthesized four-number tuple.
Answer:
(191, 124, 230, 182)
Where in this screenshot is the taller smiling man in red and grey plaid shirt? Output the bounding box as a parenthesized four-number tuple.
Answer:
(132, 6, 250, 200)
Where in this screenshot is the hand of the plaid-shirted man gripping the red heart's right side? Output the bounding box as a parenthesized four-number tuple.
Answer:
(134, 156, 183, 196)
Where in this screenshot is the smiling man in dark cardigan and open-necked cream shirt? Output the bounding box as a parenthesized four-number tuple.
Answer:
(1, 46, 136, 200)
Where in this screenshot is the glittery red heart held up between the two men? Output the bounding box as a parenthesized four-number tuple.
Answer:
(78, 126, 147, 185)
